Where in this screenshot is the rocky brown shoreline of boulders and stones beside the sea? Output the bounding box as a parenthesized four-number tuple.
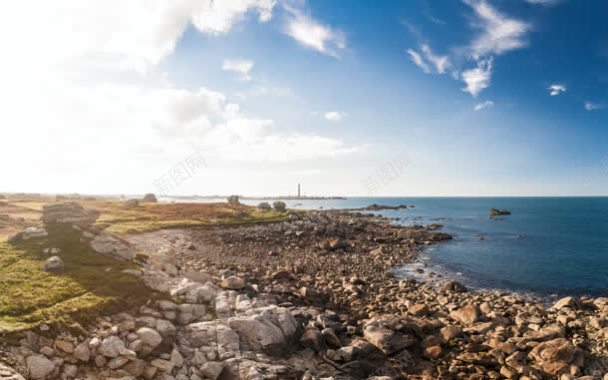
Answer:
(0, 209, 608, 380)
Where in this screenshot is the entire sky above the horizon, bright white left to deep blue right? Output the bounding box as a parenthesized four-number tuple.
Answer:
(0, 0, 608, 196)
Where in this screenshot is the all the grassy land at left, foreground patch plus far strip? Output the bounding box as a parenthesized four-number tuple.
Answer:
(0, 196, 288, 334)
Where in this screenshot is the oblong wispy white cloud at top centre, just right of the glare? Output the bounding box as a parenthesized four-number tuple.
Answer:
(285, 8, 346, 57)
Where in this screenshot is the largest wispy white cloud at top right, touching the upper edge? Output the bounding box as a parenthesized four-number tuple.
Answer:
(464, 0, 531, 59)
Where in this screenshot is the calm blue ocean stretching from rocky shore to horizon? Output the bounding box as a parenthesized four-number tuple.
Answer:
(164, 197, 608, 296)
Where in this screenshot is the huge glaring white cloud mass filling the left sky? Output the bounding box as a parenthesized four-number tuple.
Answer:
(0, 0, 359, 196)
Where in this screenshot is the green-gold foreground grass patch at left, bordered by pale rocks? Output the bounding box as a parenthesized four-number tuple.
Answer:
(0, 229, 152, 333)
